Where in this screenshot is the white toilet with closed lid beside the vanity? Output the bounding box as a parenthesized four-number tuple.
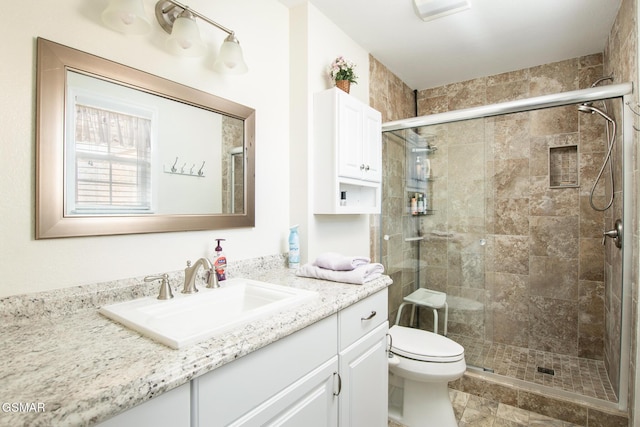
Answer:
(389, 325, 467, 427)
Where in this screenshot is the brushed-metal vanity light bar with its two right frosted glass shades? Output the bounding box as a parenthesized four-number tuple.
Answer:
(154, 0, 248, 74)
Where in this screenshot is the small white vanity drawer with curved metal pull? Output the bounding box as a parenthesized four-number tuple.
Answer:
(338, 288, 388, 351)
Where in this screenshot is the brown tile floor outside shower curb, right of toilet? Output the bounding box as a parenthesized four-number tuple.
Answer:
(389, 389, 584, 427)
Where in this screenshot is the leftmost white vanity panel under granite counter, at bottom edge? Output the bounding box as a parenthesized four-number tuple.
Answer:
(97, 383, 191, 427)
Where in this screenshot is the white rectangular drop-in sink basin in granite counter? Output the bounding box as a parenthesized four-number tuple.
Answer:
(99, 278, 317, 349)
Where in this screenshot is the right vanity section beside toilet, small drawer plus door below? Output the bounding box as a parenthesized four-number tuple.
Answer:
(338, 289, 389, 427)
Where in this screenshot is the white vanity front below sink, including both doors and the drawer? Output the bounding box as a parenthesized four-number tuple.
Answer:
(192, 289, 388, 427)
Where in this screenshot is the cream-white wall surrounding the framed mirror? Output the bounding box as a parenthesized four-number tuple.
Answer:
(0, 0, 290, 297)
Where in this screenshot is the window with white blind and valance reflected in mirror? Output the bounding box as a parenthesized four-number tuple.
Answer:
(67, 102, 151, 213)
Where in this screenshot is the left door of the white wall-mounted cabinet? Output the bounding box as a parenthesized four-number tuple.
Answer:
(337, 94, 364, 179)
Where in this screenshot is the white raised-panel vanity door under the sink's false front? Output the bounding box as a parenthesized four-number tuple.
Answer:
(229, 356, 338, 427)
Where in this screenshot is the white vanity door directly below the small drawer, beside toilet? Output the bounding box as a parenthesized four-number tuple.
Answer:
(339, 321, 389, 427)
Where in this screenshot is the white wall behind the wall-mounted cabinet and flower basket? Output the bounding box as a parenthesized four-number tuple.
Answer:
(283, 0, 369, 262)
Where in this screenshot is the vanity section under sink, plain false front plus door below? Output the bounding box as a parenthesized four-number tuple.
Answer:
(192, 315, 339, 427)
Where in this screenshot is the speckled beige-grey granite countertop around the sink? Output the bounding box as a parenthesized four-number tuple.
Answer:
(0, 262, 391, 426)
